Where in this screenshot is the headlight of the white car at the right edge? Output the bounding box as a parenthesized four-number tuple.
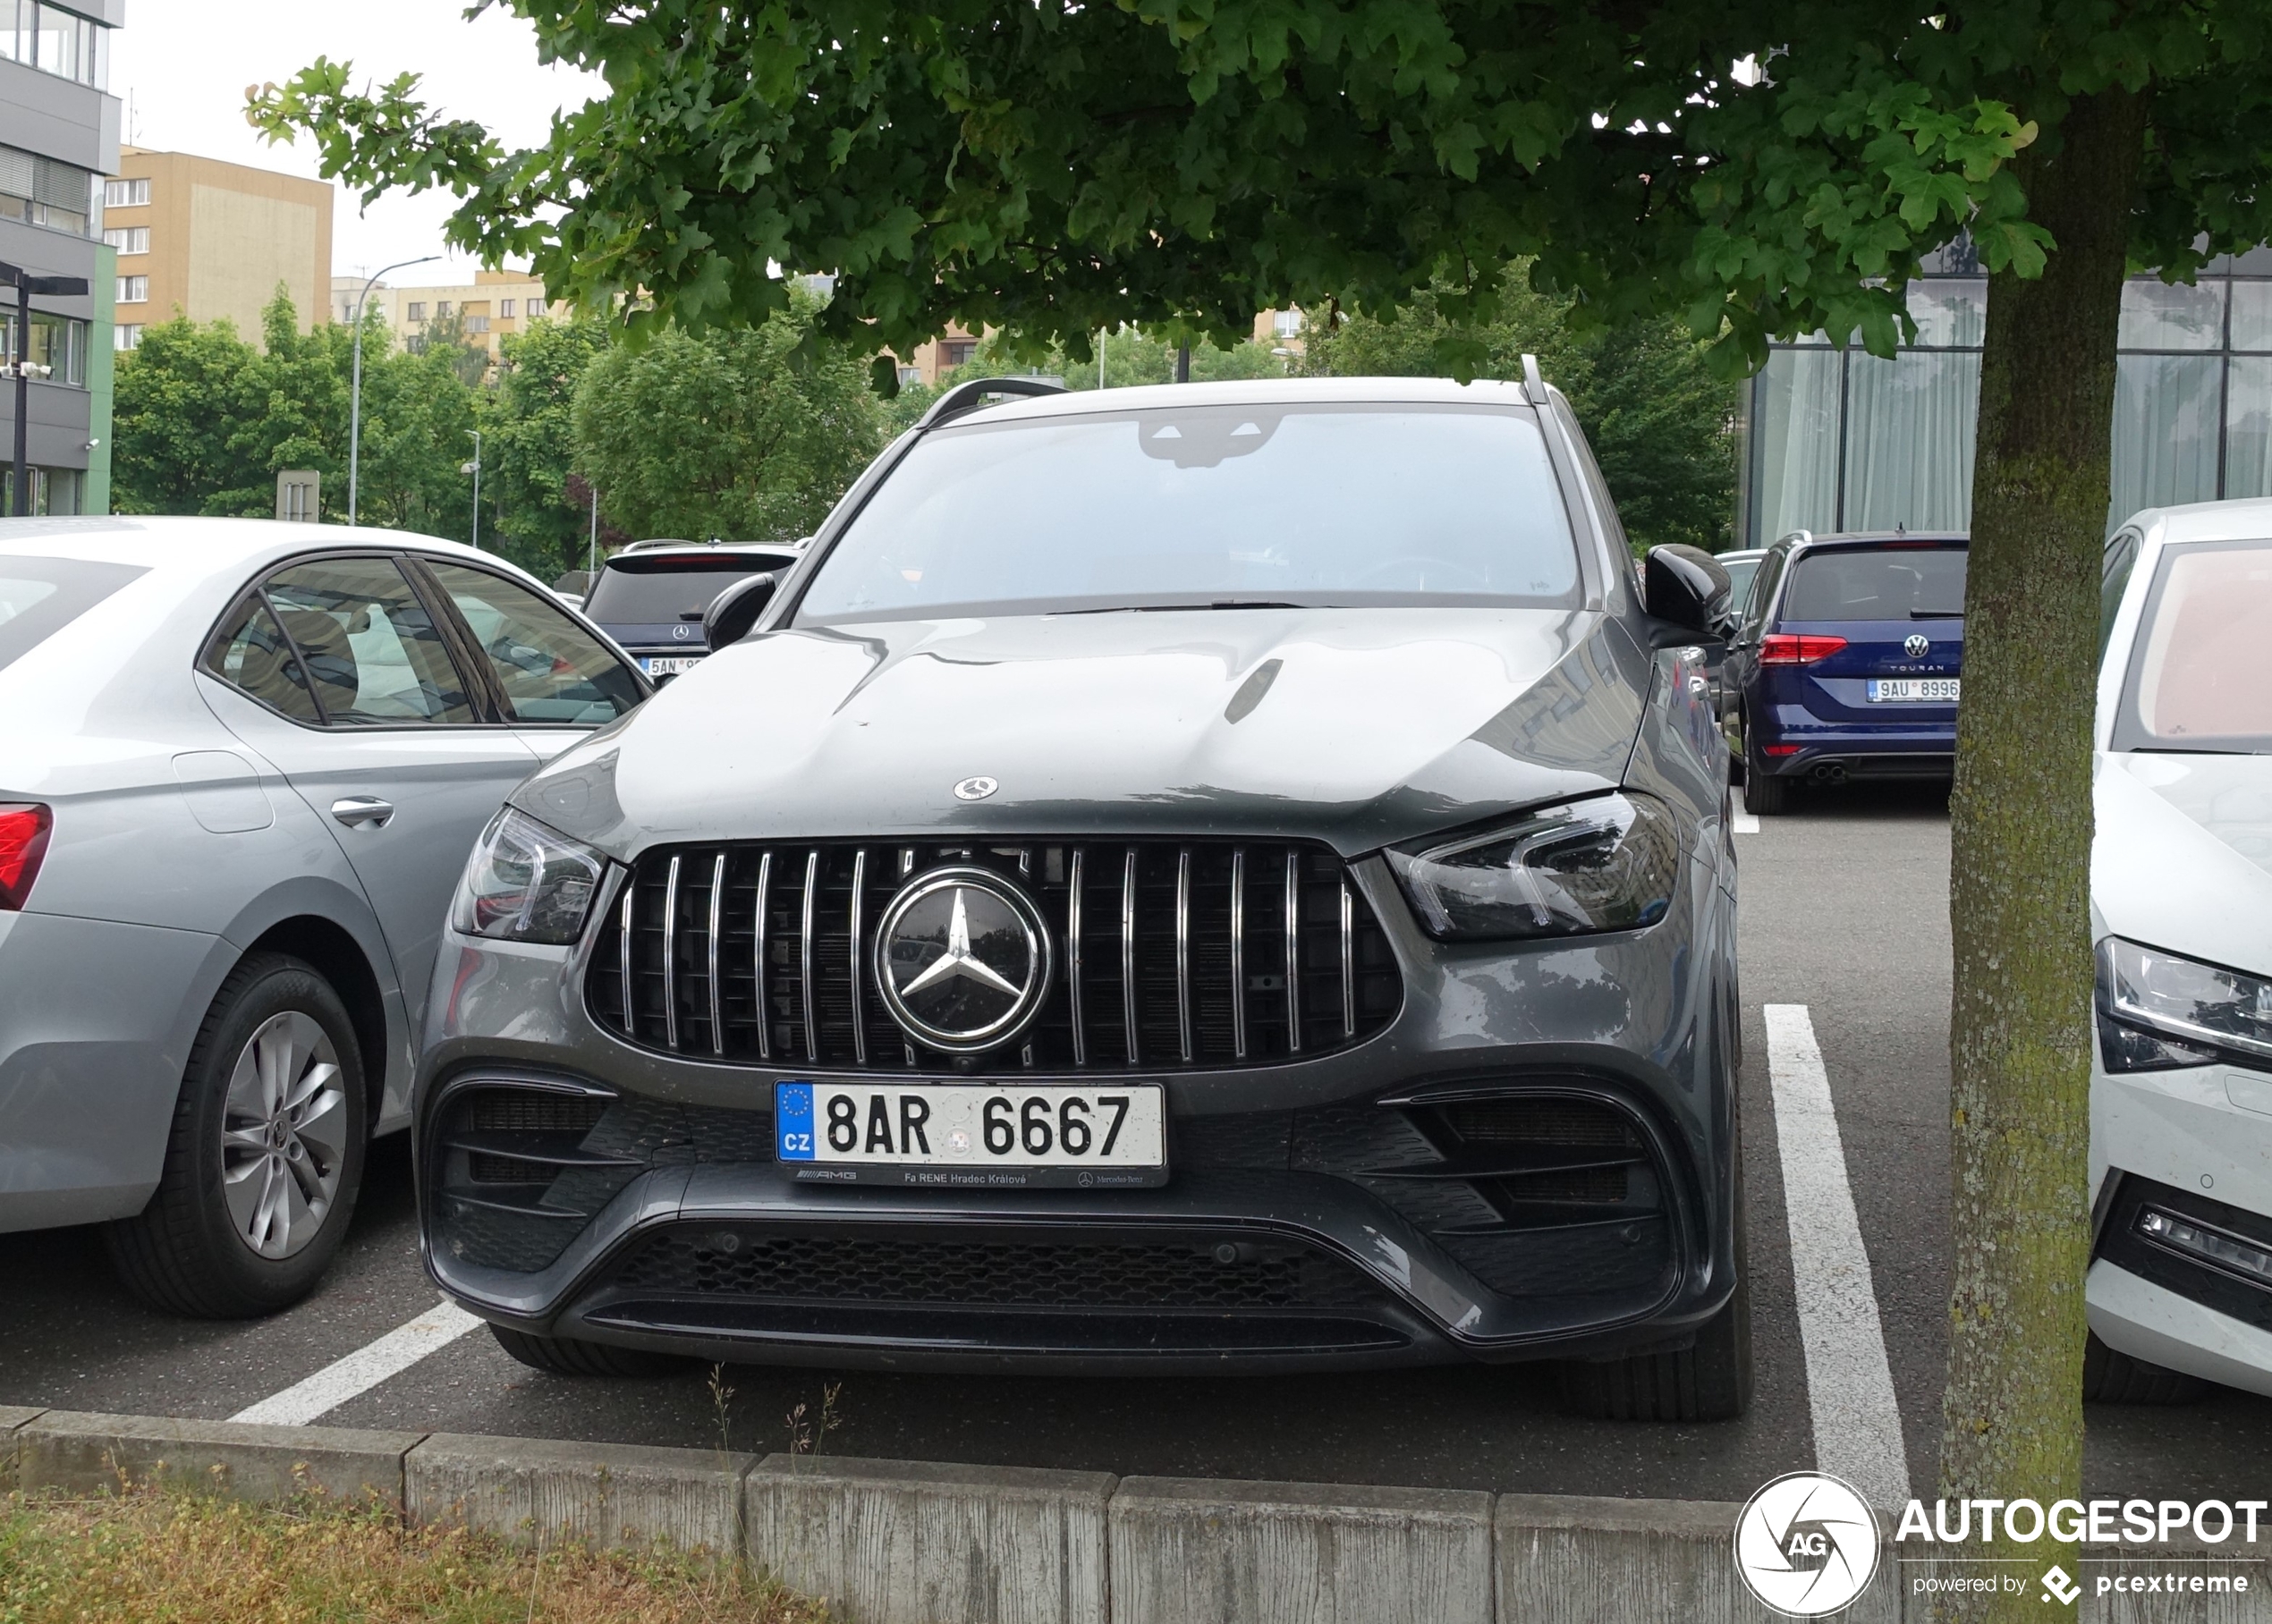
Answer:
(2099, 935, 2272, 1072)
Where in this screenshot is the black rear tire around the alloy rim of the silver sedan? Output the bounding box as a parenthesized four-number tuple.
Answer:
(102, 954, 370, 1320)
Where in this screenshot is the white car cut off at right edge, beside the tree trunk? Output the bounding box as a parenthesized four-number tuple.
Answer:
(2083, 502, 2272, 1404)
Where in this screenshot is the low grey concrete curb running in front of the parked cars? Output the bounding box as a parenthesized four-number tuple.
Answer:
(0, 1406, 2272, 1624)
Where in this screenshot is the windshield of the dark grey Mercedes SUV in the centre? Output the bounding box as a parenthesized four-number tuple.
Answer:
(798, 404, 1579, 624)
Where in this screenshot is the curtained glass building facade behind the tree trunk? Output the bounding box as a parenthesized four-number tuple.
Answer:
(1738, 245, 2272, 547)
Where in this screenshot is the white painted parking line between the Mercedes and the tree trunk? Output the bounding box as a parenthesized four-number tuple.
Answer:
(1766, 1004, 1909, 1508)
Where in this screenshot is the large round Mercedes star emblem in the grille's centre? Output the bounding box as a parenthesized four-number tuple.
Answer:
(875, 866, 1049, 1053)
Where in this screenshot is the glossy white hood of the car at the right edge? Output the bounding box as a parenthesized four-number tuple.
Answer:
(2090, 752, 2272, 975)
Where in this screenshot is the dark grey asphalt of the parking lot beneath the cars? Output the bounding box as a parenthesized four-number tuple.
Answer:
(0, 786, 2272, 1499)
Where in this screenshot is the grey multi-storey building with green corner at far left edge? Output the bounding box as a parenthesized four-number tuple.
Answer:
(0, 0, 125, 513)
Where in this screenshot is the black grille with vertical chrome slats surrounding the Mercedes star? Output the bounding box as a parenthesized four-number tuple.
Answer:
(586, 838, 1402, 1074)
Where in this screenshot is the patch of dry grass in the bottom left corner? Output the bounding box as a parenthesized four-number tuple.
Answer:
(0, 1493, 827, 1624)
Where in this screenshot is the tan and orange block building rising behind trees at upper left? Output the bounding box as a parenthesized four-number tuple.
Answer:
(107, 144, 332, 350)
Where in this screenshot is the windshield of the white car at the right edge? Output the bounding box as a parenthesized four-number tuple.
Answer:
(2115, 540, 2272, 754)
